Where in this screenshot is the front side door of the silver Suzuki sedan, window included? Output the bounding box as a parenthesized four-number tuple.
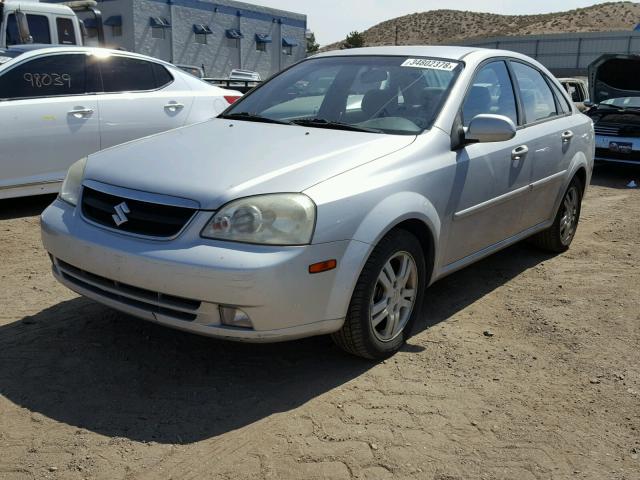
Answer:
(445, 61, 534, 265)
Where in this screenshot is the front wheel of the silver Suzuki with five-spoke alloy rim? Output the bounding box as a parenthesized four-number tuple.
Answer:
(331, 230, 427, 360)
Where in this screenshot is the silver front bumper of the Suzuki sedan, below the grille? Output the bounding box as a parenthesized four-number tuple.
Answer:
(41, 200, 369, 342)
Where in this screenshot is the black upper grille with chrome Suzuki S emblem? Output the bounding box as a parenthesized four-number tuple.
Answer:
(82, 187, 196, 238)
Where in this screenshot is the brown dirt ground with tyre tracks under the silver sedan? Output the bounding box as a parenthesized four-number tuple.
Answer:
(0, 166, 640, 480)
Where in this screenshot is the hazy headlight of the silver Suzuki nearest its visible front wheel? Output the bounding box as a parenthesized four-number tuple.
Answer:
(202, 193, 316, 245)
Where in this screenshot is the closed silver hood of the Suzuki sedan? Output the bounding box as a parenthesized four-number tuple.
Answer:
(85, 119, 416, 210)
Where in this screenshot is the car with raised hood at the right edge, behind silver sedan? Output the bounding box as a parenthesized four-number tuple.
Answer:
(587, 54, 640, 165)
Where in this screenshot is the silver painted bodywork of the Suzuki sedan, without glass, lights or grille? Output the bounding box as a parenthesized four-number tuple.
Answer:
(42, 47, 594, 341)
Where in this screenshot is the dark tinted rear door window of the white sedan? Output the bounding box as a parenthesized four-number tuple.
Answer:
(99, 56, 173, 93)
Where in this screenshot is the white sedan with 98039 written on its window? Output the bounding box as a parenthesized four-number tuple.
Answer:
(0, 45, 241, 198)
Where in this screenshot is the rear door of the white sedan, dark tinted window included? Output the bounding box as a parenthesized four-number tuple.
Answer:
(98, 55, 193, 148)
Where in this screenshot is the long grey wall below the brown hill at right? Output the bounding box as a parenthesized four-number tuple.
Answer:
(462, 30, 640, 77)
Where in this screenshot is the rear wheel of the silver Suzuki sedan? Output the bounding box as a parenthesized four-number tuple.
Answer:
(531, 177, 584, 253)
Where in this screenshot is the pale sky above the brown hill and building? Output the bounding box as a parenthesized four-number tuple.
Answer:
(250, 0, 624, 45)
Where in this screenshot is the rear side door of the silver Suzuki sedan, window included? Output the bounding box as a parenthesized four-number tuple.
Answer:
(511, 61, 578, 229)
